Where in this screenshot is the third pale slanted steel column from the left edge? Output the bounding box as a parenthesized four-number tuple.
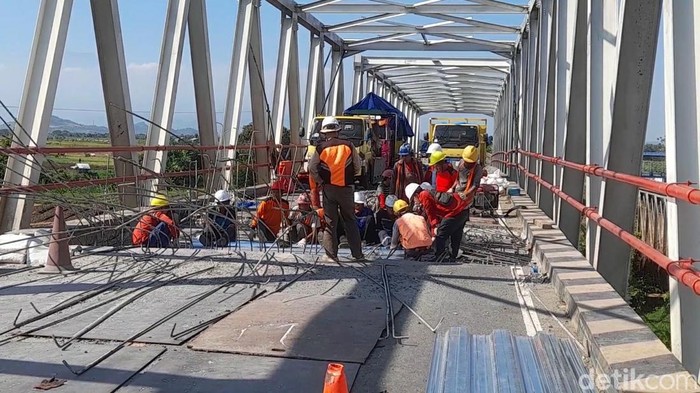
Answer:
(221, 0, 257, 187)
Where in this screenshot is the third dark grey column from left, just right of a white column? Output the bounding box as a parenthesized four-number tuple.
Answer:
(248, 3, 276, 184)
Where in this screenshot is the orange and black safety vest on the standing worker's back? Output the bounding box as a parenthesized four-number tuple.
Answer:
(316, 138, 355, 187)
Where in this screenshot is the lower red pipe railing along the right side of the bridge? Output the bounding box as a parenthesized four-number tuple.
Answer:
(507, 163, 700, 295)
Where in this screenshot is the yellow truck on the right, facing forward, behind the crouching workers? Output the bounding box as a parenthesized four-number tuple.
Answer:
(428, 117, 488, 165)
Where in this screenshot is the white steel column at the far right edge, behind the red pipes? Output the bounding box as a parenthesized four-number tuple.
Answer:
(663, 1, 700, 375)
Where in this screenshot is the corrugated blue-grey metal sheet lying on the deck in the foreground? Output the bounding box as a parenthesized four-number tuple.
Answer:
(427, 327, 593, 393)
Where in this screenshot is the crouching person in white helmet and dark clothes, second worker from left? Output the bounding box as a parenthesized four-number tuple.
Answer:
(199, 190, 236, 247)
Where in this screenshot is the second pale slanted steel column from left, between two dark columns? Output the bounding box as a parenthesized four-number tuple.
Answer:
(143, 0, 190, 196)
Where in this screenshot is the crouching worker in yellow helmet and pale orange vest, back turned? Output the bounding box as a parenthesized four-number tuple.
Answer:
(391, 199, 433, 258)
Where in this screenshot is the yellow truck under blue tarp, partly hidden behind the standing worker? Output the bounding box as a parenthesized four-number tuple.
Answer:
(306, 116, 384, 189)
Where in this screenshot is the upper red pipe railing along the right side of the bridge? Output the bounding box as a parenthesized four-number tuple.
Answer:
(517, 150, 700, 205)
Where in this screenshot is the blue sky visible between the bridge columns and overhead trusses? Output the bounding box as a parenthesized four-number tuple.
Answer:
(0, 0, 664, 141)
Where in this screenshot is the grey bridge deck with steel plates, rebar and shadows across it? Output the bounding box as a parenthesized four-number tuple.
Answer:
(0, 198, 584, 392)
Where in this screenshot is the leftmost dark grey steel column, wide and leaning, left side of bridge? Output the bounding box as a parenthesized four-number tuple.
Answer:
(90, 0, 139, 207)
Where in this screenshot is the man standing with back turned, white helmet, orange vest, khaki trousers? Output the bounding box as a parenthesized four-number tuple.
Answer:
(309, 116, 365, 261)
